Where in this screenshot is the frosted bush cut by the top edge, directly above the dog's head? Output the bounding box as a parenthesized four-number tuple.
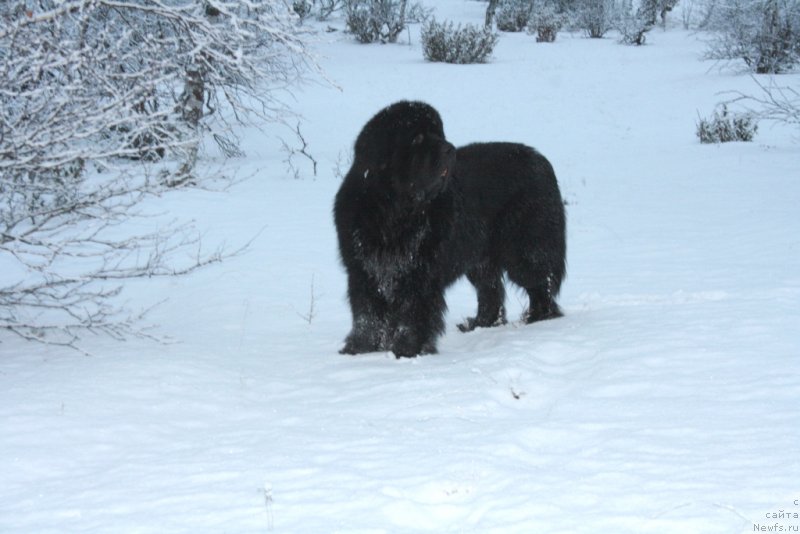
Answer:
(344, 0, 429, 43)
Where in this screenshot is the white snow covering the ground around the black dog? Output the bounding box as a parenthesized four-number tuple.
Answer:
(0, 0, 800, 533)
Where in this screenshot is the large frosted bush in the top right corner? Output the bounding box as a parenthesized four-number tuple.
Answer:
(706, 0, 800, 74)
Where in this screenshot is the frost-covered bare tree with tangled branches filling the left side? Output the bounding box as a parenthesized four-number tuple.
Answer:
(0, 0, 314, 352)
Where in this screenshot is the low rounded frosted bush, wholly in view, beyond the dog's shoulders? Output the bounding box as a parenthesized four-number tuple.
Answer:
(420, 19, 498, 64)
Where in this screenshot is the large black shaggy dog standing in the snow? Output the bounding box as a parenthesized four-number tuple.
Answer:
(334, 101, 566, 357)
